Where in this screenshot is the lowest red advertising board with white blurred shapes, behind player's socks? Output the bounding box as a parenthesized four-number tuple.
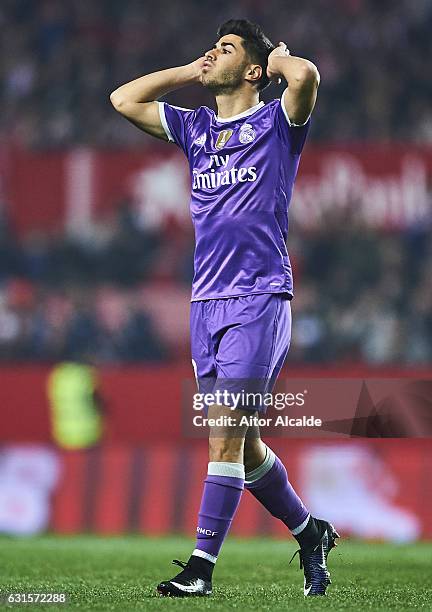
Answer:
(0, 439, 432, 542)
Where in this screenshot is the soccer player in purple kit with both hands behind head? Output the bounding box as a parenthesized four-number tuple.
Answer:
(111, 20, 339, 597)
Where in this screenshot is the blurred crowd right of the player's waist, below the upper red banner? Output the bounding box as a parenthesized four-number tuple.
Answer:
(289, 216, 432, 366)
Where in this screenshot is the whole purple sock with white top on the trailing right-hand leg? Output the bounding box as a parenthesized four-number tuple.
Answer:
(245, 446, 310, 539)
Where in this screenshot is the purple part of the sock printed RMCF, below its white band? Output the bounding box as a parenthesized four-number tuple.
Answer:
(195, 476, 244, 557)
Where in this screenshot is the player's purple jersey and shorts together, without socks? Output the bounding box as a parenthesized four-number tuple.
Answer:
(159, 97, 310, 410)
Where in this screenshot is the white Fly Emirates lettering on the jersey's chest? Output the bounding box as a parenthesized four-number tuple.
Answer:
(192, 155, 257, 190)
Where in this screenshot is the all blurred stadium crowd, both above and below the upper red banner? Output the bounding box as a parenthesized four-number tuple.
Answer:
(0, 0, 432, 365)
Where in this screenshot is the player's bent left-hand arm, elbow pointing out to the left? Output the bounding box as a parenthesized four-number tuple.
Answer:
(110, 57, 205, 140)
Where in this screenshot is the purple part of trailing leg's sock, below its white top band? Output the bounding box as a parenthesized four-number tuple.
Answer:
(245, 457, 309, 529)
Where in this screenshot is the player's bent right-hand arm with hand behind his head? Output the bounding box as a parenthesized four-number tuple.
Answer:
(267, 43, 320, 125)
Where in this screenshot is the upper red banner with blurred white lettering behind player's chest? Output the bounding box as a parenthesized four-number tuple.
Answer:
(0, 145, 432, 233)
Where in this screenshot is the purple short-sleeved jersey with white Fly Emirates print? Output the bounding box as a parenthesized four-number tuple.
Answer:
(159, 94, 310, 301)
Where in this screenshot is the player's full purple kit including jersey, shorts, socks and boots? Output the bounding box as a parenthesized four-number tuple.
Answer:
(153, 86, 338, 596)
